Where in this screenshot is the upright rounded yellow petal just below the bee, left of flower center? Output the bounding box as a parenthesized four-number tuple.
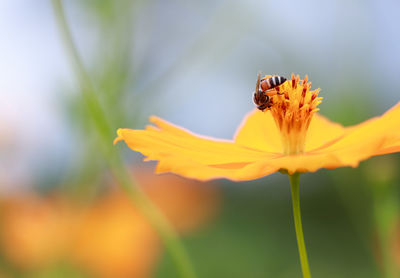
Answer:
(234, 109, 283, 153)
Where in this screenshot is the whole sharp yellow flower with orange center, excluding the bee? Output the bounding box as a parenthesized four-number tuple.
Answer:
(114, 75, 400, 181)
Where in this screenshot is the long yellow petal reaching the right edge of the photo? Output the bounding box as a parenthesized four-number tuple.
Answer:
(268, 102, 400, 173)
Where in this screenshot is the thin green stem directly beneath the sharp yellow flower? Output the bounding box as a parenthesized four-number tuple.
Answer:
(289, 173, 311, 278)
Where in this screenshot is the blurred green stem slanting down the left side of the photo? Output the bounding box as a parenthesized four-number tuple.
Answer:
(52, 0, 196, 278)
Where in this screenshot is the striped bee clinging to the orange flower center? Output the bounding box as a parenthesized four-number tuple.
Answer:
(253, 73, 286, 111)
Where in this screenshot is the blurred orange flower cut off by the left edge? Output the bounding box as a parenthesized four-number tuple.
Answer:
(0, 195, 72, 269)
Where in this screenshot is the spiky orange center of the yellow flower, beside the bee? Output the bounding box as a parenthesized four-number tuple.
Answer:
(266, 74, 322, 155)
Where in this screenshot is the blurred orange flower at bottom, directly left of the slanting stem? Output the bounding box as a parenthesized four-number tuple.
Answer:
(70, 193, 161, 278)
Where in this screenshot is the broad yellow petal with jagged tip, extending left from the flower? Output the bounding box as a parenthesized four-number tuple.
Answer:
(116, 117, 278, 180)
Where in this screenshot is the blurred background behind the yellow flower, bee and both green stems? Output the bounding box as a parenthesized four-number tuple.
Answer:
(0, 0, 400, 278)
